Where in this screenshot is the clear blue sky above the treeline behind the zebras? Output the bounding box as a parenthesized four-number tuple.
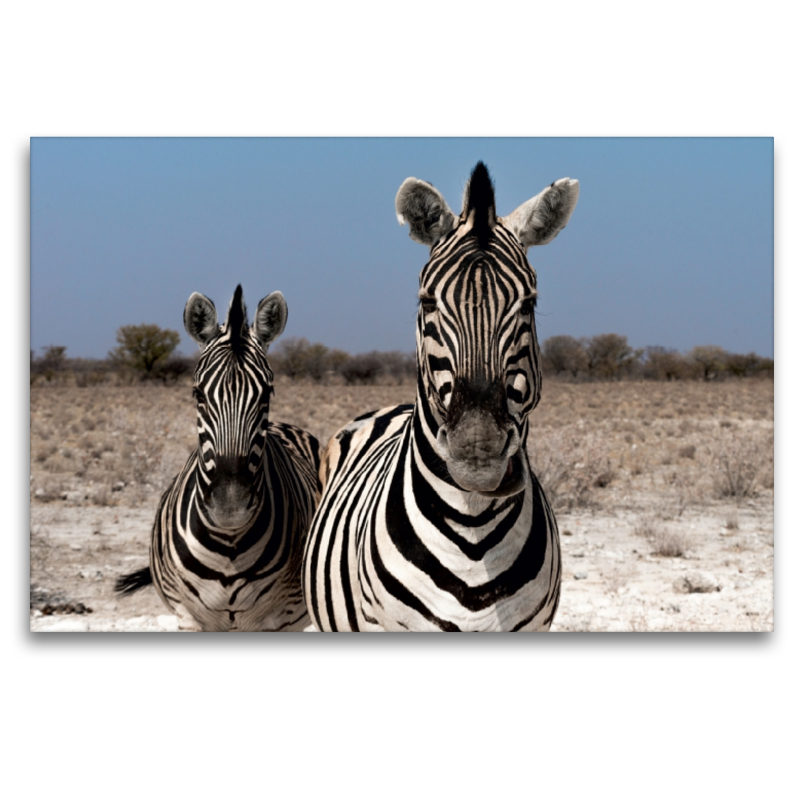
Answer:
(31, 138, 773, 357)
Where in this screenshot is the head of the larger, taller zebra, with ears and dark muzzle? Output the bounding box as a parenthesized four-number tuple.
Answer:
(395, 162, 579, 497)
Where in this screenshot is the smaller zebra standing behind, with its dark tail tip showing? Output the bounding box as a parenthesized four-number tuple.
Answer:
(116, 285, 320, 631)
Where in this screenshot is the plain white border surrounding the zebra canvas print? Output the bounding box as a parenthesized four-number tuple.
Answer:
(9, 2, 800, 797)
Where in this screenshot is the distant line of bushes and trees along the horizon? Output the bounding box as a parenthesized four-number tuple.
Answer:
(30, 325, 774, 386)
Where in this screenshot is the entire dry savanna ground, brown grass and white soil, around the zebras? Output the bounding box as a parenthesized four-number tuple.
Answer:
(30, 378, 774, 631)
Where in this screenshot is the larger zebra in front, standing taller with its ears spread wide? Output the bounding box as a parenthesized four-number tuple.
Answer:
(303, 162, 579, 631)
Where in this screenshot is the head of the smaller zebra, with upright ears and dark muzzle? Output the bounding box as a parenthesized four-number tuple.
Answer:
(183, 286, 288, 530)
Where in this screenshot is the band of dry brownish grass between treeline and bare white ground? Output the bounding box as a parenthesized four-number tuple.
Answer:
(30, 377, 774, 516)
